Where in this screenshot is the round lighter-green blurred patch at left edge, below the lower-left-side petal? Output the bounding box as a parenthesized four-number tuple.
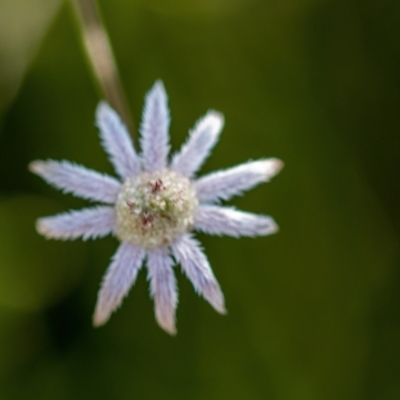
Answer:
(0, 196, 83, 310)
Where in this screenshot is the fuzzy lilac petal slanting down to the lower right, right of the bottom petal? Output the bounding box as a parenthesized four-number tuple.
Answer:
(172, 234, 226, 314)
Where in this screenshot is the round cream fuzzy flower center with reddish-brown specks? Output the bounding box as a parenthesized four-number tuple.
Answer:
(115, 170, 198, 249)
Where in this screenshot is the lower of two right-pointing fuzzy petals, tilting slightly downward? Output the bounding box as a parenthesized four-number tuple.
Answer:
(194, 205, 278, 237)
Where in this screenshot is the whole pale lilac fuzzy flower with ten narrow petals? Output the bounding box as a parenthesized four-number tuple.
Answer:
(29, 81, 283, 334)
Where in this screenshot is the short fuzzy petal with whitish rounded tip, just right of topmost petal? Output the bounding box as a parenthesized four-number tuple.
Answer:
(171, 111, 224, 178)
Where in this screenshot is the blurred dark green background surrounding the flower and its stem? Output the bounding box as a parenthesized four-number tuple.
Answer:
(0, 0, 400, 400)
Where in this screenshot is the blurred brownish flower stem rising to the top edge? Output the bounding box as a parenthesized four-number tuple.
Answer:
(71, 0, 135, 134)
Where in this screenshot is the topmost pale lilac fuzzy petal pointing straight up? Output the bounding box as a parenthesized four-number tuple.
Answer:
(140, 81, 170, 171)
